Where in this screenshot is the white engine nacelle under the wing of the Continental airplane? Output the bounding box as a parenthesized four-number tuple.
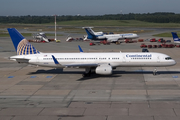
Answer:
(95, 64, 112, 75)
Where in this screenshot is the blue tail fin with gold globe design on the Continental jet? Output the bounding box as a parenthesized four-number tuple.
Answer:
(7, 28, 40, 55)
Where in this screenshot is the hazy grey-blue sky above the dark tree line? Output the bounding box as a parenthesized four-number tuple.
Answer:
(0, 0, 180, 16)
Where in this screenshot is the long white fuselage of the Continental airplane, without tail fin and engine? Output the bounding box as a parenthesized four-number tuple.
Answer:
(10, 52, 176, 68)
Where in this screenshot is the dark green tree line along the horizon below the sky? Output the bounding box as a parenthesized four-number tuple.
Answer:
(0, 12, 180, 24)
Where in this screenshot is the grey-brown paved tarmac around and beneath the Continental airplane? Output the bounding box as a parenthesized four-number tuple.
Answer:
(0, 27, 180, 120)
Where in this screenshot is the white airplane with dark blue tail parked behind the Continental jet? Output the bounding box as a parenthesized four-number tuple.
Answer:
(83, 27, 139, 42)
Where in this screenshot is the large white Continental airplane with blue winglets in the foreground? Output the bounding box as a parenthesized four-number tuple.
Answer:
(7, 28, 176, 77)
